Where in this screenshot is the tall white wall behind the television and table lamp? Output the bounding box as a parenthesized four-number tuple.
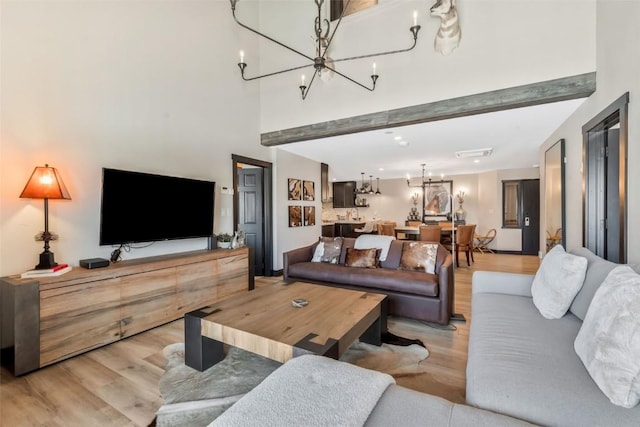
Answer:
(0, 0, 271, 276)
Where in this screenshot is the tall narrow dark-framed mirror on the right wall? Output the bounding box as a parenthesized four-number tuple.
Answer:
(544, 139, 566, 252)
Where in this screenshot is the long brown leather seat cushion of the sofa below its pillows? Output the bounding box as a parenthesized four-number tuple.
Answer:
(289, 262, 439, 297)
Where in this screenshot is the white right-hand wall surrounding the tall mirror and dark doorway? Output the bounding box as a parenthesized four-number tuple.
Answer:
(540, 0, 640, 263)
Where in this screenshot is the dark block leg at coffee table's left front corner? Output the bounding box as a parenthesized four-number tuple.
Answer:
(184, 310, 224, 372)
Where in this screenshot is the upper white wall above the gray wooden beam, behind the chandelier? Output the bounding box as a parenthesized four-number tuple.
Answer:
(255, 0, 595, 132)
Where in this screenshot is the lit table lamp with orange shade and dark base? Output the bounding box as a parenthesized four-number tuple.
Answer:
(20, 164, 71, 270)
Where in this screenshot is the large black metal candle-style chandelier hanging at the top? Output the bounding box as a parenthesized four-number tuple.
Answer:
(229, 0, 420, 100)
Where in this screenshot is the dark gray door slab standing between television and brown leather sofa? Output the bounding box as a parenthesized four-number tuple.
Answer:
(238, 167, 265, 276)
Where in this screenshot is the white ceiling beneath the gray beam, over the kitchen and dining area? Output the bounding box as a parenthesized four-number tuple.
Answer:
(278, 98, 585, 181)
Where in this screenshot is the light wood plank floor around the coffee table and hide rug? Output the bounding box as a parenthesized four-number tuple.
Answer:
(0, 254, 539, 427)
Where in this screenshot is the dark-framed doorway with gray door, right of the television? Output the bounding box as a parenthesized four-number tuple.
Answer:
(231, 154, 273, 276)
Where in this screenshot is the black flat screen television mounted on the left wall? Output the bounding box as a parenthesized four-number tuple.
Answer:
(100, 168, 216, 245)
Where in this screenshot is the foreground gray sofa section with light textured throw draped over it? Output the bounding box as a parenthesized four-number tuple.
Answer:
(209, 355, 531, 427)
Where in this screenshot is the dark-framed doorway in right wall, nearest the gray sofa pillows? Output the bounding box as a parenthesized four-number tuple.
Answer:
(582, 92, 629, 263)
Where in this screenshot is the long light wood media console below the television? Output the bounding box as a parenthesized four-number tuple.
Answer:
(0, 248, 254, 375)
